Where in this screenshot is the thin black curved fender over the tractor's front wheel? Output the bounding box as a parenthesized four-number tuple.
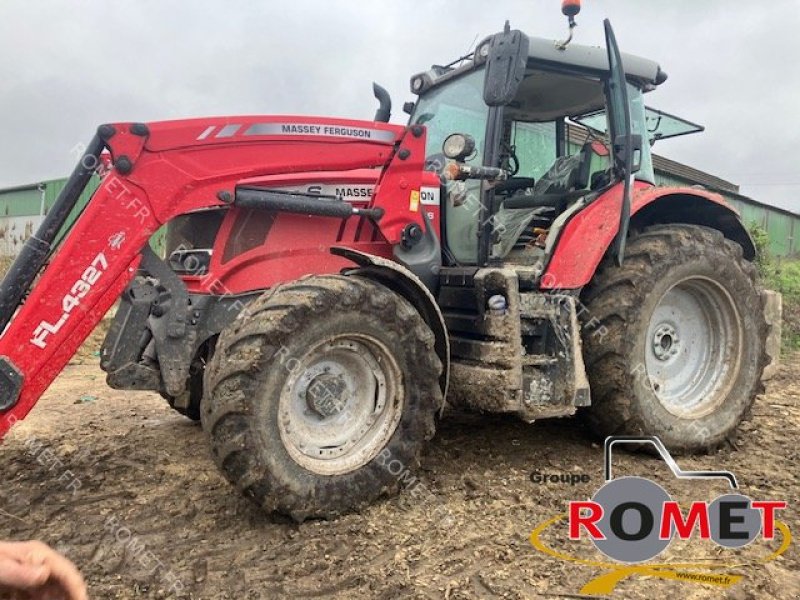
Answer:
(331, 246, 450, 408)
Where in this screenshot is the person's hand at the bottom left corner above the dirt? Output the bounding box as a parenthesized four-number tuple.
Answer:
(0, 542, 89, 600)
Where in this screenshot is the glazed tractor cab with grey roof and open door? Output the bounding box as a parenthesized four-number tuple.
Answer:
(411, 25, 671, 266)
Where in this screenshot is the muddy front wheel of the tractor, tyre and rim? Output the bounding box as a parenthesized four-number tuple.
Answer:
(201, 276, 442, 521)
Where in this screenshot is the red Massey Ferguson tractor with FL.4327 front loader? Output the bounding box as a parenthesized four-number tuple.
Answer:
(0, 0, 767, 520)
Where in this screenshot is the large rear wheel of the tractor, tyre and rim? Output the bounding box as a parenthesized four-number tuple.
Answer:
(583, 225, 767, 452)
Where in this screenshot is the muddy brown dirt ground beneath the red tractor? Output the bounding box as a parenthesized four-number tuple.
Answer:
(0, 344, 800, 600)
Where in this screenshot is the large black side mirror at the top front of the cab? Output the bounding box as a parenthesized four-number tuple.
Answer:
(481, 22, 530, 106)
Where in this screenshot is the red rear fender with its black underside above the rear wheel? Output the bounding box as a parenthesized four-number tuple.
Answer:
(541, 182, 756, 290)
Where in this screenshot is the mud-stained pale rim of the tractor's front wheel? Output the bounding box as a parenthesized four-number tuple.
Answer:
(278, 334, 404, 475)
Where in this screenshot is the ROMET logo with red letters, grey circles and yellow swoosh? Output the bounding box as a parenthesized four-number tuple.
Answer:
(531, 437, 791, 594)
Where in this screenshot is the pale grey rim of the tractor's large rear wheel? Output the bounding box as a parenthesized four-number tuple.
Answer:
(645, 277, 742, 418)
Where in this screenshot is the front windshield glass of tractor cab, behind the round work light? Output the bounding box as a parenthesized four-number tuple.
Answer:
(411, 69, 489, 264)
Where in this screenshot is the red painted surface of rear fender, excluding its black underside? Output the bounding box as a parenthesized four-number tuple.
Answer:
(541, 181, 735, 290)
